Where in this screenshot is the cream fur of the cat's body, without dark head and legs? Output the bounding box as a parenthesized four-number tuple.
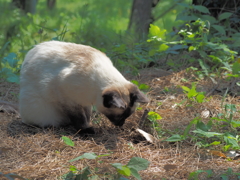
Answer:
(19, 41, 131, 128)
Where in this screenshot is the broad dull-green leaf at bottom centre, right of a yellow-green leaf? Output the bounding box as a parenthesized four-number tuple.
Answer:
(127, 157, 150, 171)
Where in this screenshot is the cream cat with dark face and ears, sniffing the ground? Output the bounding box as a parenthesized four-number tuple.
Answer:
(16, 41, 148, 133)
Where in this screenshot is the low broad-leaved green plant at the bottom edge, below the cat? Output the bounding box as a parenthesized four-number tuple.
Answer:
(62, 153, 150, 180)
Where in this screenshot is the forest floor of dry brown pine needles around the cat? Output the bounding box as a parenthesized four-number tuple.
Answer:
(0, 68, 240, 180)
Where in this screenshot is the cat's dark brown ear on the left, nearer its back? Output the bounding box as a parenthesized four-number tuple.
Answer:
(102, 91, 126, 109)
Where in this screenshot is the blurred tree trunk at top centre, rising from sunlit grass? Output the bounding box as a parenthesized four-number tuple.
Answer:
(128, 0, 159, 39)
